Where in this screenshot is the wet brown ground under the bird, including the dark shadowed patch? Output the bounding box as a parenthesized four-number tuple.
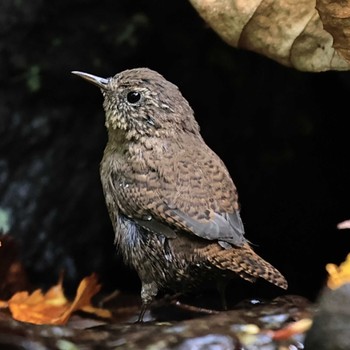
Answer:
(0, 295, 314, 350)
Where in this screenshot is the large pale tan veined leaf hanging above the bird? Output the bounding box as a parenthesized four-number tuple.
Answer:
(190, 0, 350, 72)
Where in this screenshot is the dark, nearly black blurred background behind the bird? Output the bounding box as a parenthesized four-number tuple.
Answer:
(0, 0, 350, 299)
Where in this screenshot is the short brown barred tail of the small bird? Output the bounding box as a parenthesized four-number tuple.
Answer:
(196, 243, 288, 289)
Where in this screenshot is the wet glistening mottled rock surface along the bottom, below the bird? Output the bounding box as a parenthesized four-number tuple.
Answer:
(0, 296, 312, 350)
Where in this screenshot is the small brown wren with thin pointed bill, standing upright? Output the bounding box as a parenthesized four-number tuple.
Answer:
(72, 68, 287, 321)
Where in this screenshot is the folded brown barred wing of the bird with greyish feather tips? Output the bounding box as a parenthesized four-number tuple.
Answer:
(110, 135, 245, 246)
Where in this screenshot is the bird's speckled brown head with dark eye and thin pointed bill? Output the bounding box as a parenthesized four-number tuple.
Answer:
(72, 68, 199, 139)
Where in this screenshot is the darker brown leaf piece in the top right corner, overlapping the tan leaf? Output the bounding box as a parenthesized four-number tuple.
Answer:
(316, 0, 350, 61)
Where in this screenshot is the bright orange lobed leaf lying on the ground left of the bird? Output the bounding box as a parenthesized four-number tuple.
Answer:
(0, 274, 111, 325)
